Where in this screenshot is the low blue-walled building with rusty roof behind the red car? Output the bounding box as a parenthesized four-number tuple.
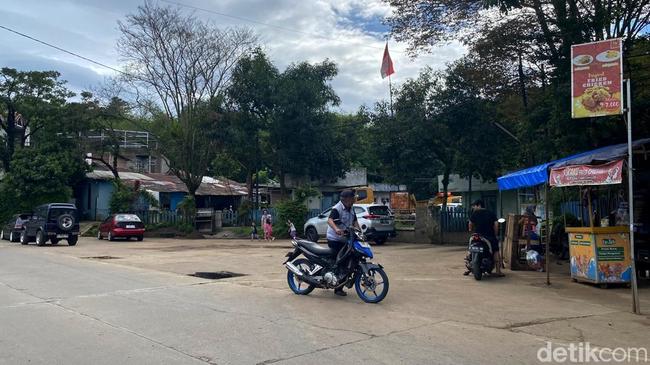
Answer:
(76, 170, 248, 220)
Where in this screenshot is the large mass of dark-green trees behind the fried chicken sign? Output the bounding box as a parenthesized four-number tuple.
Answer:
(380, 0, 650, 181)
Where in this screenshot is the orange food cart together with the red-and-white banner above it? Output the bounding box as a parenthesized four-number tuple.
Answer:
(550, 139, 650, 286)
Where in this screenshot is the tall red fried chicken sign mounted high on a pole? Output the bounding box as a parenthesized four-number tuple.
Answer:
(571, 39, 623, 118)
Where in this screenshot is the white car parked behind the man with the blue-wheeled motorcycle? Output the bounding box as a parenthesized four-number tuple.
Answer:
(304, 204, 396, 245)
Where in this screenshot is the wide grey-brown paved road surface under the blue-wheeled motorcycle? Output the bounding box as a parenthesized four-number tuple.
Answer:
(0, 239, 650, 364)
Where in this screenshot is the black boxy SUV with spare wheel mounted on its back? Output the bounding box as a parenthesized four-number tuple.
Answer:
(20, 203, 79, 246)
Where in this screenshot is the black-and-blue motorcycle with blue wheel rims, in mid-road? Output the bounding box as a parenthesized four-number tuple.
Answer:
(284, 223, 388, 303)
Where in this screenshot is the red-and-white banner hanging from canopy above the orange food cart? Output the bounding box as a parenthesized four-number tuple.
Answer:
(550, 160, 623, 187)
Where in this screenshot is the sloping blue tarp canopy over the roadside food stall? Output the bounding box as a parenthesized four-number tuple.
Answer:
(497, 138, 650, 190)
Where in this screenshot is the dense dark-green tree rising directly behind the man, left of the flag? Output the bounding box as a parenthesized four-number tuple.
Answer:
(268, 60, 349, 197)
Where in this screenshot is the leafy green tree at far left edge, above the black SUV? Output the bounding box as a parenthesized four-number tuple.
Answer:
(0, 67, 73, 172)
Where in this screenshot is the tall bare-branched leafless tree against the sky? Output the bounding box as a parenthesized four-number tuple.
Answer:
(118, 1, 256, 205)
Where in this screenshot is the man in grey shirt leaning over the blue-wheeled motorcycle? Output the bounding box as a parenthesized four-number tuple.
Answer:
(327, 189, 360, 296)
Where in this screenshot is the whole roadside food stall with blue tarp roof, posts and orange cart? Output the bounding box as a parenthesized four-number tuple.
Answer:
(497, 139, 650, 284)
